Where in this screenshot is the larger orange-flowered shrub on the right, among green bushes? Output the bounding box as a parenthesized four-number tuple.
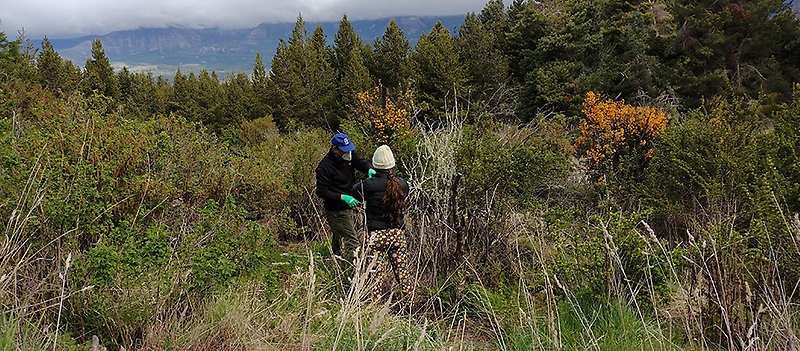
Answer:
(574, 92, 669, 180)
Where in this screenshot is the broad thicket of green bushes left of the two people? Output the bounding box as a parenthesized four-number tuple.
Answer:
(0, 82, 300, 346)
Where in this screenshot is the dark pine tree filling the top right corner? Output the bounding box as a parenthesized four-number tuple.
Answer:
(653, 0, 800, 107)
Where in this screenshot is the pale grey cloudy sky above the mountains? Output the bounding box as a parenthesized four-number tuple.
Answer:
(0, 0, 488, 39)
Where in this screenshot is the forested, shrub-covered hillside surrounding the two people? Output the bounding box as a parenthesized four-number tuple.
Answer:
(0, 0, 800, 350)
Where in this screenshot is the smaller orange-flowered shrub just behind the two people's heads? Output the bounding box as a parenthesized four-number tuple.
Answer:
(357, 84, 413, 144)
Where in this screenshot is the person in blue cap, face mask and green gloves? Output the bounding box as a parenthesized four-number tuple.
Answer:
(316, 133, 375, 263)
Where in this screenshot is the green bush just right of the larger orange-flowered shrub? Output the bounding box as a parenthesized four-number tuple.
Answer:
(637, 97, 783, 237)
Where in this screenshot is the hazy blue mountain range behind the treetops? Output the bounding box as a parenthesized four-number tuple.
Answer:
(43, 16, 464, 78)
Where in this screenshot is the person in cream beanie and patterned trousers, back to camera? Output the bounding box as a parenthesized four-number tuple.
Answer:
(353, 145, 413, 301)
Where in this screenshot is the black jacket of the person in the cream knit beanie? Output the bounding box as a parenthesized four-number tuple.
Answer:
(353, 172, 408, 231)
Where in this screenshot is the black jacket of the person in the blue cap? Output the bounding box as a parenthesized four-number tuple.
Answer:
(316, 150, 372, 211)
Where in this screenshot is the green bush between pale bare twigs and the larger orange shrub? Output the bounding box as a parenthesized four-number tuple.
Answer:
(450, 119, 570, 285)
